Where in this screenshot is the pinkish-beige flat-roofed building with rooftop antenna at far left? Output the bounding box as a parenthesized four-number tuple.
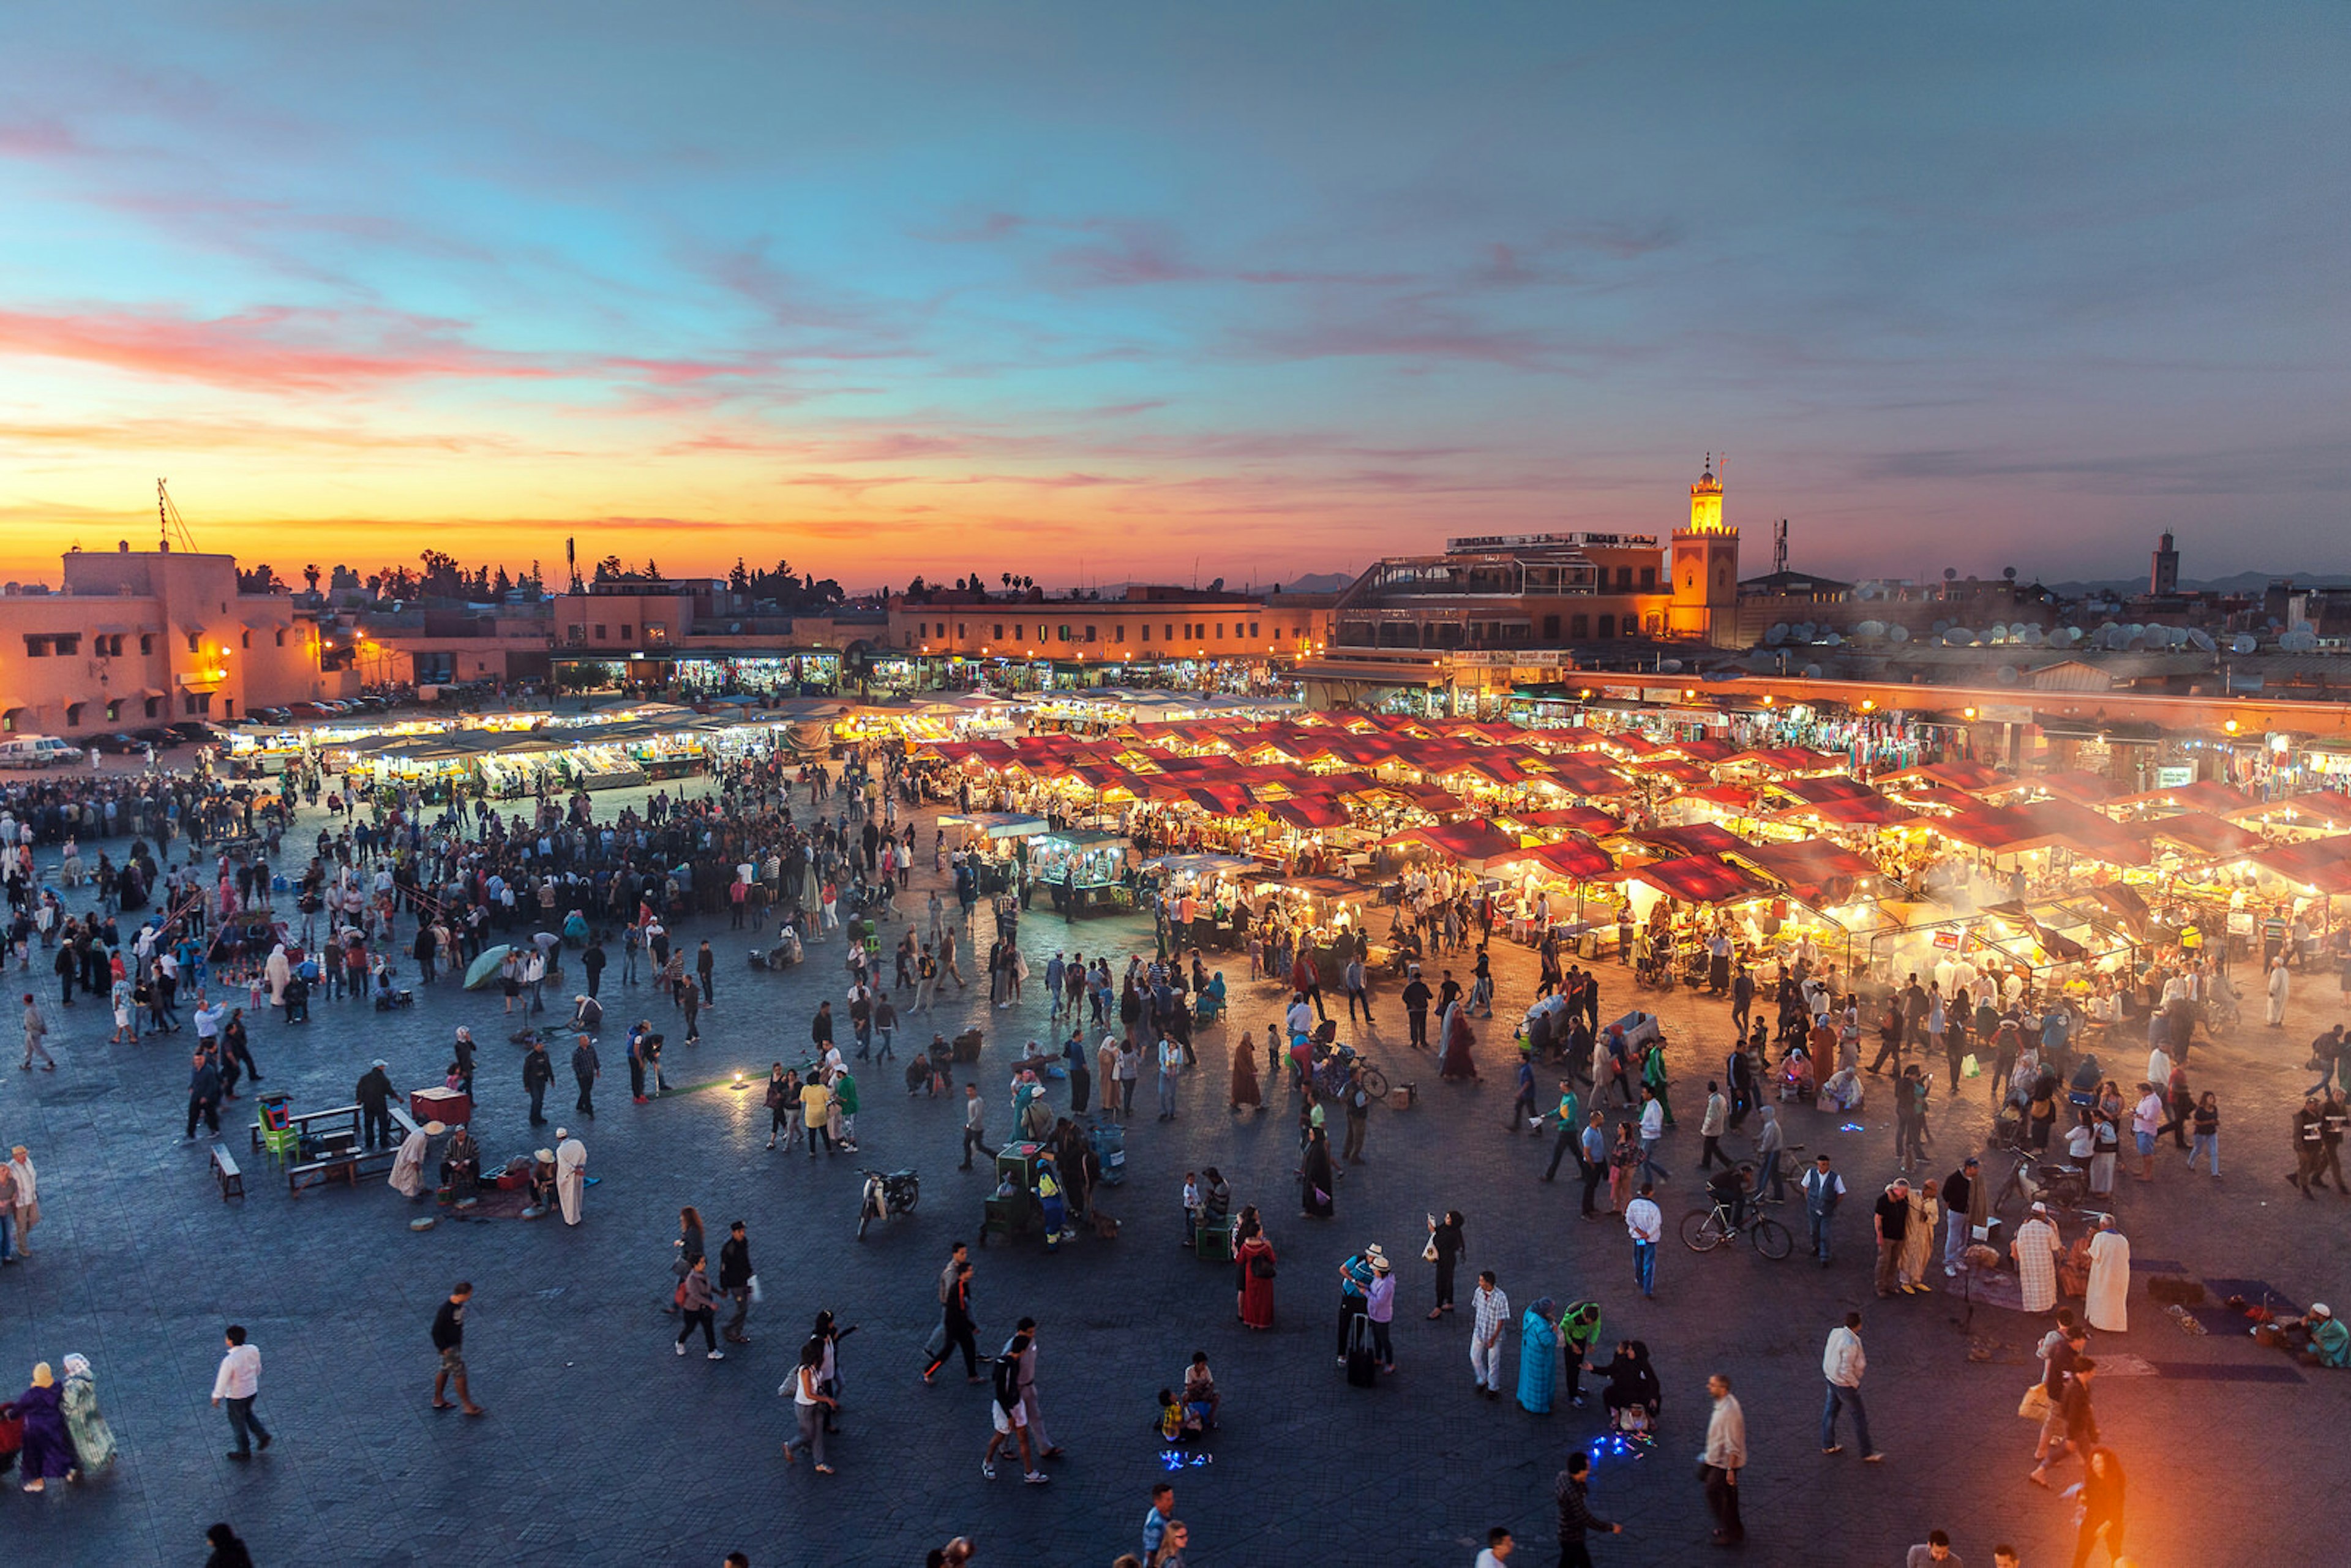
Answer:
(0, 543, 343, 738)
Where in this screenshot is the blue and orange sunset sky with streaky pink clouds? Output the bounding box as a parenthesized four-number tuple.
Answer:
(0, 0, 2351, 588)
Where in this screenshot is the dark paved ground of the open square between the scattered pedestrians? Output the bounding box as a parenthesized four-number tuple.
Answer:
(0, 797, 2351, 1568)
